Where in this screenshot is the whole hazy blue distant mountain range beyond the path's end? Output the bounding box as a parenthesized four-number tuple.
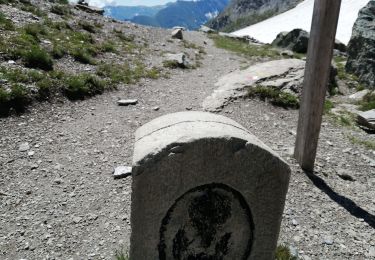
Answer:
(105, 0, 229, 30)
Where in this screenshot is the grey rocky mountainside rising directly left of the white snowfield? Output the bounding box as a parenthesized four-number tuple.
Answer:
(207, 0, 302, 32)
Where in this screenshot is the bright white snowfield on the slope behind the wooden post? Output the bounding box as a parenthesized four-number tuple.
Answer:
(233, 0, 369, 44)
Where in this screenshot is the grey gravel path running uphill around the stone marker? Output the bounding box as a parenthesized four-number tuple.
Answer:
(0, 30, 375, 260)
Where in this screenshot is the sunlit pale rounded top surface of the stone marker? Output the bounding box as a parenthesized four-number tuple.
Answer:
(133, 111, 285, 166)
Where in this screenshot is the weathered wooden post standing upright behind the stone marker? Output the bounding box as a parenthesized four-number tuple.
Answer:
(294, 0, 341, 171)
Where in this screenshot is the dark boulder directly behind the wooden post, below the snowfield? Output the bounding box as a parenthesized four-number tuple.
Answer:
(272, 29, 346, 53)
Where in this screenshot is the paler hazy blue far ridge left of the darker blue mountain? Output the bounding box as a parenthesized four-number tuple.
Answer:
(104, 5, 166, 20)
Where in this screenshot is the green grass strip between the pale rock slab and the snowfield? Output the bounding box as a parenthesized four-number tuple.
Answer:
(210, 34, 280, 58)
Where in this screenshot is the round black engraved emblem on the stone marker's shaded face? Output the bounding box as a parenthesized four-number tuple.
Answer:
(158, 183, 254, 260)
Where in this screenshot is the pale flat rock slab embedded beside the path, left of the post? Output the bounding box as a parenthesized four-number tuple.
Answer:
(202, 59, 305, 112)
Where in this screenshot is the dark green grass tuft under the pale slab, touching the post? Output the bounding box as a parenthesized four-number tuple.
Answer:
(247, 86, 299, 108)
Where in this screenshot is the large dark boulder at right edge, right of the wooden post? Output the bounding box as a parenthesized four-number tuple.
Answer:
(346, 1, 375, 89)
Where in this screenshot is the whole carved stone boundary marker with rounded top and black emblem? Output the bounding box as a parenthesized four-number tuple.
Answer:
(130, 112, 290, 260)
